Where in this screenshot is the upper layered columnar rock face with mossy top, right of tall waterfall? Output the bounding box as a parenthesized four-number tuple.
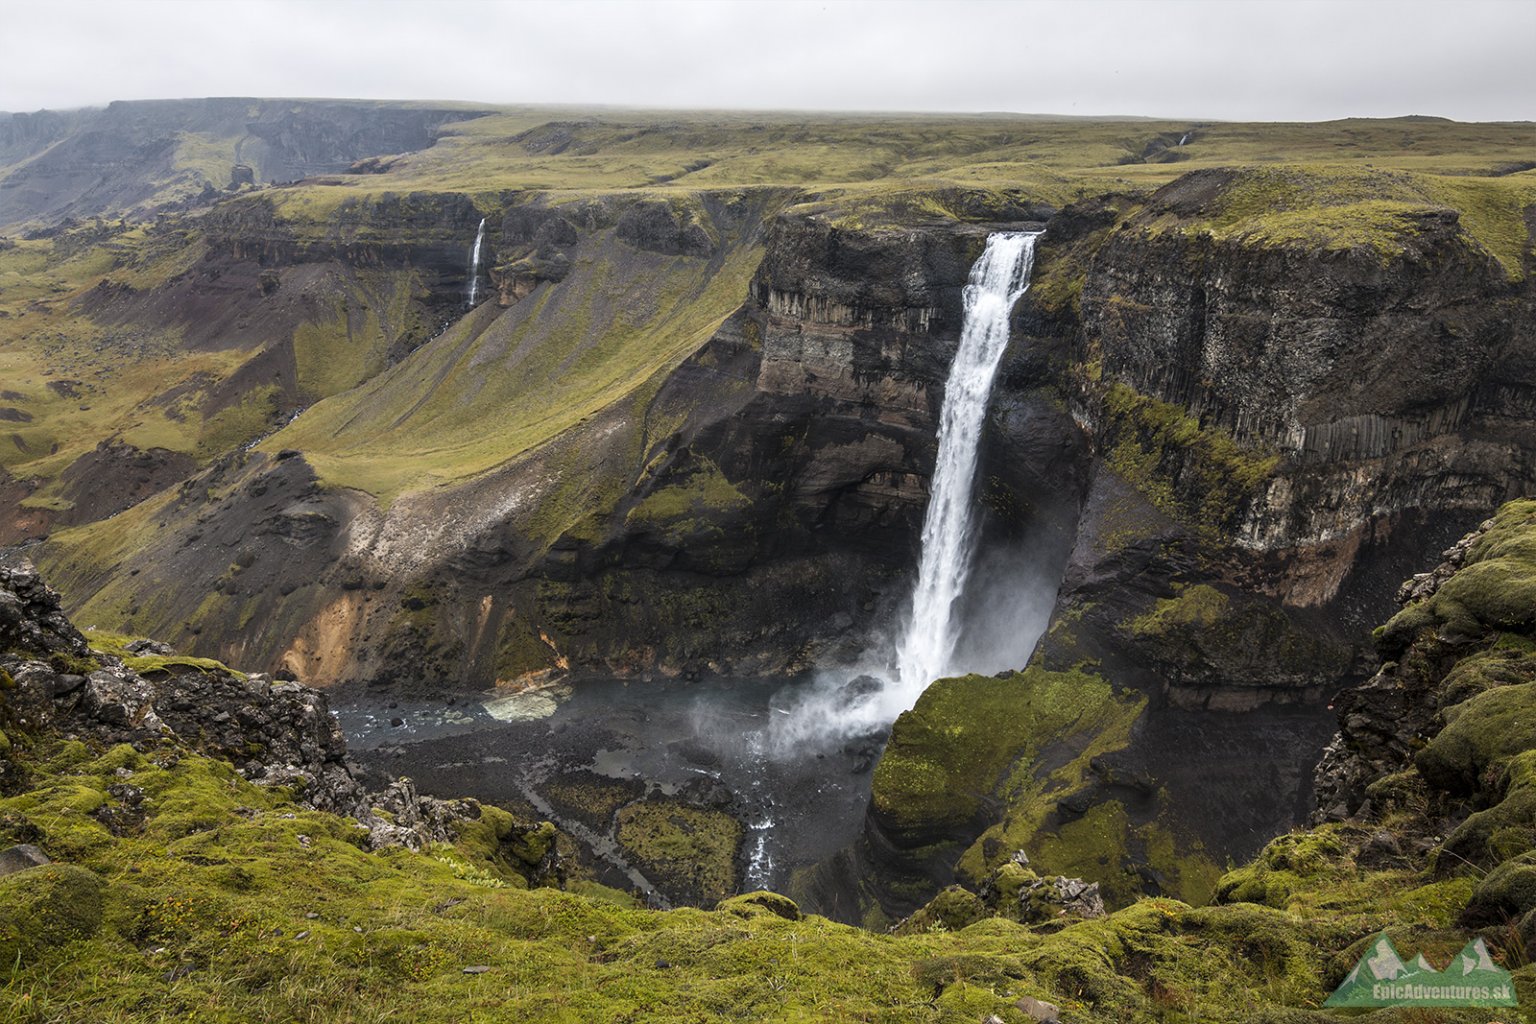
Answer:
(1025, 172, 1536, 706)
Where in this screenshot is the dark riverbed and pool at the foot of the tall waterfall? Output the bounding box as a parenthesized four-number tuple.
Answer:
(333, 679, 880, 904)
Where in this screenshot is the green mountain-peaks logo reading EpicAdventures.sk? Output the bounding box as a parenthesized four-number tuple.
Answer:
(1322, 932, 1518, 1007)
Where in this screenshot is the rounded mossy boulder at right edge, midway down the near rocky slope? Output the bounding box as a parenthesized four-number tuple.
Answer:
(1415, 683, 1536, 794)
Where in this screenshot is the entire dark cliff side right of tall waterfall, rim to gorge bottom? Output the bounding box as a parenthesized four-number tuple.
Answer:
(863, 172, 1536, 912)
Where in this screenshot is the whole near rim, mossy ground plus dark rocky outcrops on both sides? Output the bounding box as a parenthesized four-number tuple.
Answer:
(0, 515, 1536, 1024)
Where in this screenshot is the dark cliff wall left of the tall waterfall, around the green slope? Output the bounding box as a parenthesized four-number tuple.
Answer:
(27, 192, 1084, 688)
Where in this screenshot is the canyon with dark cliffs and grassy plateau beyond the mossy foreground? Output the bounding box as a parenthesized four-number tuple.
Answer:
(0, 100, 1536, 1019)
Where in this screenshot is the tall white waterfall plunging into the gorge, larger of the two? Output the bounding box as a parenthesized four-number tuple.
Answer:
(895, 232, 1040, 708)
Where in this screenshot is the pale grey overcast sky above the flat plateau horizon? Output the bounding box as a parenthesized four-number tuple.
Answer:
(0, 0, 1536, 121)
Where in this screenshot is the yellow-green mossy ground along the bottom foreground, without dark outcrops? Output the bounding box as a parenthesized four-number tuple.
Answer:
(0, 742, 1536, 1022)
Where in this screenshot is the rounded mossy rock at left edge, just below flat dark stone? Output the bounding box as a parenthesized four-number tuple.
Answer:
(0, 864, 106, 964)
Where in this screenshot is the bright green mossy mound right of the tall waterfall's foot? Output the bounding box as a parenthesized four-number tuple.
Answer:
(871, 666, 1179, 903)
